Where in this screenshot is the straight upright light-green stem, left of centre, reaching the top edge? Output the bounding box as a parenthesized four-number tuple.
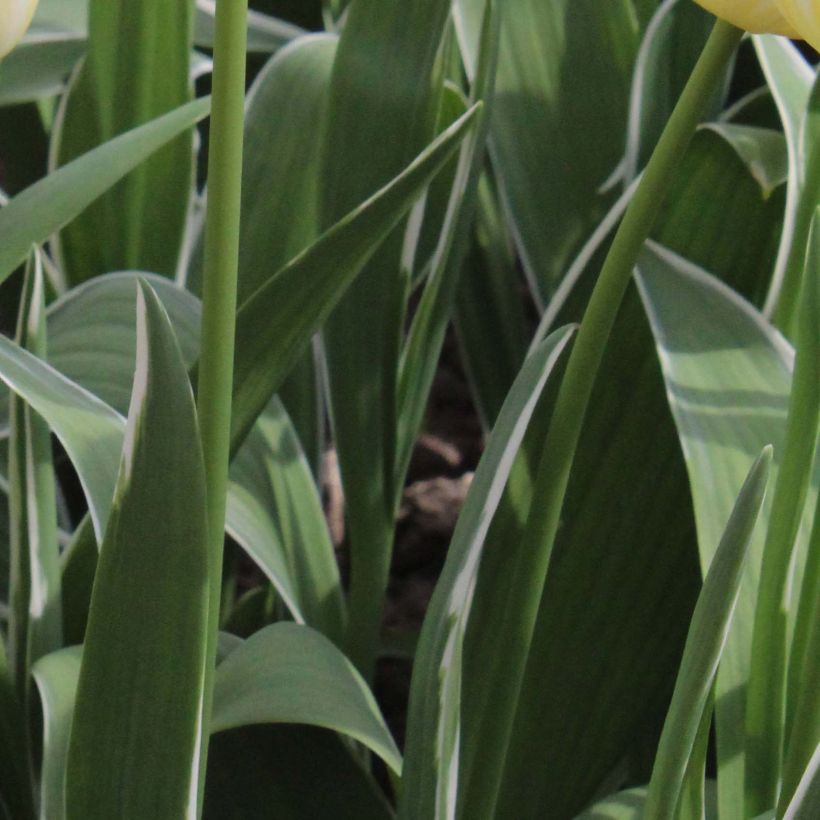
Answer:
(197, 0, 248, 814)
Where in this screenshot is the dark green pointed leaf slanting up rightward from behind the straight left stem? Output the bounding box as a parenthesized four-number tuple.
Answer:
(231, 106, 480, 450)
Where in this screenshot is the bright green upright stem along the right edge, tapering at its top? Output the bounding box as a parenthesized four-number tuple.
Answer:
(746, 213, 820, 817)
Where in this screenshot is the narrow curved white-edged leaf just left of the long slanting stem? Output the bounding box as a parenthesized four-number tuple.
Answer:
(401, 329, 571, 820)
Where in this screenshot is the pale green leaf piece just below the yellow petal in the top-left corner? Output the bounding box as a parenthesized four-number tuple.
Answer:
(0, 34, 86, 105)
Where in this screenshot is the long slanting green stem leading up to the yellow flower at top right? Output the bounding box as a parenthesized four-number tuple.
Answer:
(462, 21, 742, 817)
